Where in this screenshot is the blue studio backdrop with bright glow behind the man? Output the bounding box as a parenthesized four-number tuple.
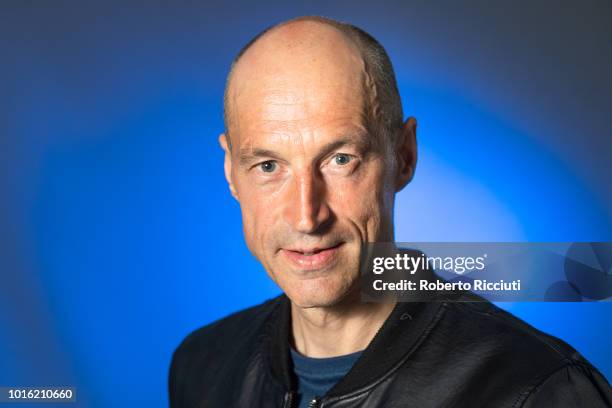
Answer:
(0, 1, 612, 407)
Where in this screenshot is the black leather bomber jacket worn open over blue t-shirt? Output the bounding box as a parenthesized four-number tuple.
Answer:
(169, 295, 612, 408)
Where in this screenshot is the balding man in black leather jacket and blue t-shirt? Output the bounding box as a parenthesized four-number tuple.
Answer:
(169, 17, 612, 408)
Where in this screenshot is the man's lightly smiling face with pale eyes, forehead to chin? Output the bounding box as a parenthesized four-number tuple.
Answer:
(220, 23, 416, 307)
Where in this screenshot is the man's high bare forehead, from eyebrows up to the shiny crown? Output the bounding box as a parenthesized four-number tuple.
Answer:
(227, 24, 366, 144)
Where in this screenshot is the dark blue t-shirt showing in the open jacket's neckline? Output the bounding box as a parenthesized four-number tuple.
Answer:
(291, 348, 361, 408)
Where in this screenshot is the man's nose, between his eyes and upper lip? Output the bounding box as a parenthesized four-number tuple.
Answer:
(285, 170, 331, 234)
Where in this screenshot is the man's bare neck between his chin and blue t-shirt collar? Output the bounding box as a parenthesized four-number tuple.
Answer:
(291, 290, 395, 358)
